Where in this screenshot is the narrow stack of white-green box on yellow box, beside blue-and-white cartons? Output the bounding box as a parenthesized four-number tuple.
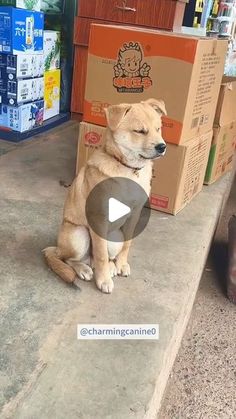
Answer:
(43, 31, 61, 120)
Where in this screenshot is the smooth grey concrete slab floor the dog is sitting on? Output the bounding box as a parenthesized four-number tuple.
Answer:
(0, 122, 233, 419)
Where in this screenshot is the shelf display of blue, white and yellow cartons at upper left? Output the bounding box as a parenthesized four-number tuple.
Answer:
(0, 0, 74, 142)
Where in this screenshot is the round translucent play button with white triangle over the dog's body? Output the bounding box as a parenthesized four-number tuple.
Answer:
(85, 177, 151, 243)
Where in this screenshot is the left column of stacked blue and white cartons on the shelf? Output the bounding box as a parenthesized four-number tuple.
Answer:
(0, 6, 44, 132)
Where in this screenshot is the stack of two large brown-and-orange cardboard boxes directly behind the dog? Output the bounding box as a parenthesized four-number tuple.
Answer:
(77, 24, 227, 214)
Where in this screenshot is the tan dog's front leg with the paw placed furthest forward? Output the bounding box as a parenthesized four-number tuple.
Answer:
(90, 229, 114, 294)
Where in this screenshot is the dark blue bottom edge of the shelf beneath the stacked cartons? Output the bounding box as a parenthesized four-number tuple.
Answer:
(0, 112, 70, 143)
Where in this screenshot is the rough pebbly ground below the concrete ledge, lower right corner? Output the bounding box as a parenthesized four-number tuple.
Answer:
(158, 178, 236, 419)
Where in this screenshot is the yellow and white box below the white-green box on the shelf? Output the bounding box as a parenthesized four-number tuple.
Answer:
(44, 70, 61, 121)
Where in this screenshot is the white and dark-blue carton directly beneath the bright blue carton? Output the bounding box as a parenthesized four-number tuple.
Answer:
(0, 53, 44, 80)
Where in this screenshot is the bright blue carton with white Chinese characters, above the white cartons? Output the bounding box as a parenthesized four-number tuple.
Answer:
(0, 7, 44, 54)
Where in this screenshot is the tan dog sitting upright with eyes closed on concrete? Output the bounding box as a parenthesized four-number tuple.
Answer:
(44, 99, 166, 293)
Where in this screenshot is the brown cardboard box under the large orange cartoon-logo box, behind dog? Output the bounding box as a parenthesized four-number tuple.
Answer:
(76, 122, 212, 214)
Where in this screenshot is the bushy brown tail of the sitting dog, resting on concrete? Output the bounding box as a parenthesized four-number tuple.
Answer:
(43, 247, 76, 284)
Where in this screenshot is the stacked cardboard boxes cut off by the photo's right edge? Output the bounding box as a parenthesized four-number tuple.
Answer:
(204, 77, 236, 184)
